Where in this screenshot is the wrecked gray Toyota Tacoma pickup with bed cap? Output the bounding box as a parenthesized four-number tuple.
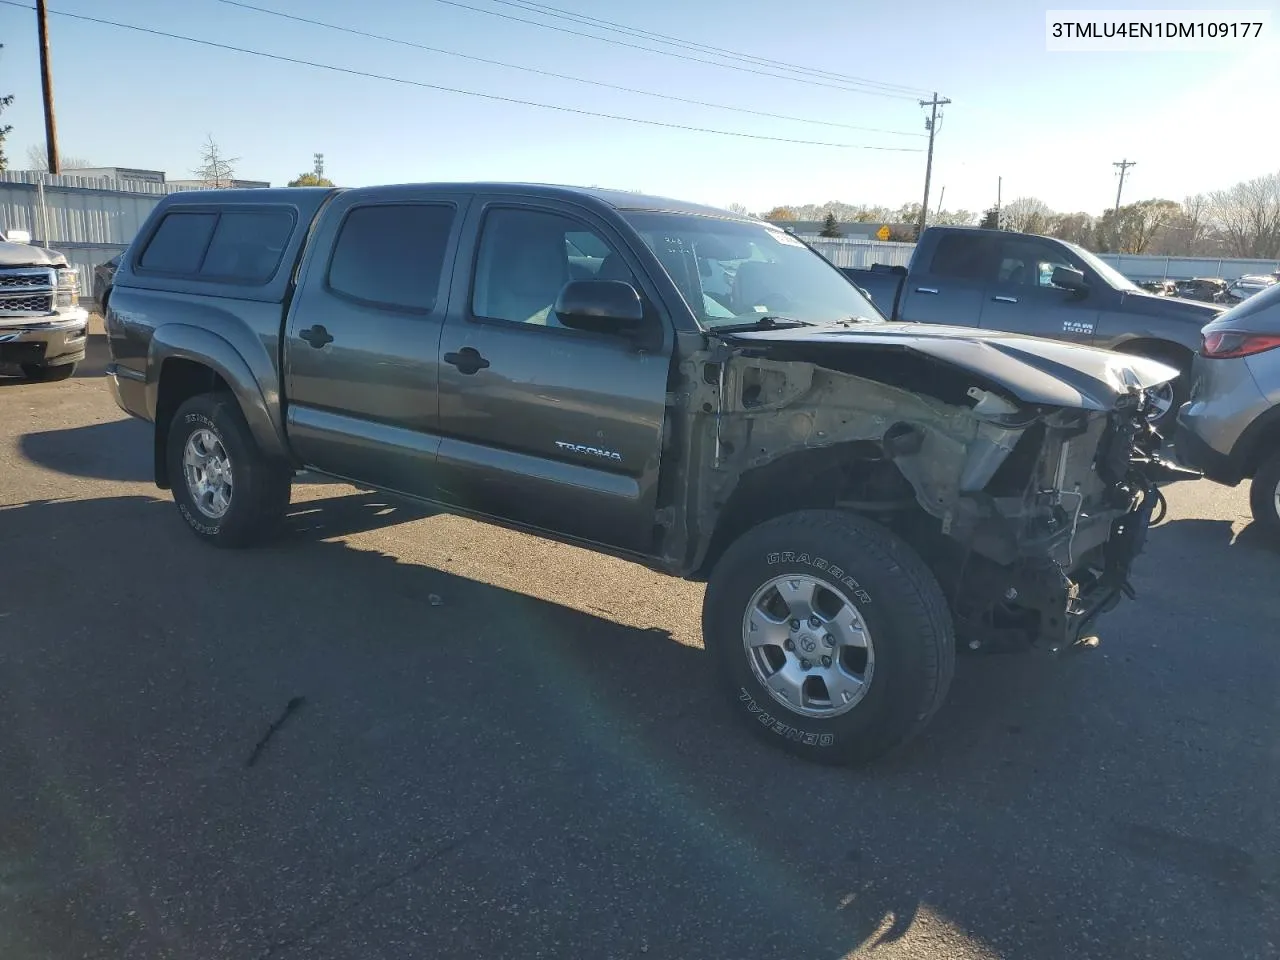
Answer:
(106, 184, 1175, 763)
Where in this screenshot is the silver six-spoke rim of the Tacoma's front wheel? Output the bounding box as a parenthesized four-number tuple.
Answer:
(742, 573, 876, 718)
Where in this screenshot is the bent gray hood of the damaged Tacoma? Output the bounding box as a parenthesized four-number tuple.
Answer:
(719, 323, 1178, 411)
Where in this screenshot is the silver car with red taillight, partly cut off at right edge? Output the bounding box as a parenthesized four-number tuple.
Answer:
(1175, 284, 1280, 539)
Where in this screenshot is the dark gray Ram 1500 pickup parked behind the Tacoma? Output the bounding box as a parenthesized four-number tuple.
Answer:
(844, 227, 1225, 433)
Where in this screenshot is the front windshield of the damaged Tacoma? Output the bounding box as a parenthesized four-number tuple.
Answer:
(623, 211, 883, 329)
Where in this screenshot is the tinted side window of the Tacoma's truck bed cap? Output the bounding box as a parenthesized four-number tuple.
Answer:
(138, 207, 294, 284)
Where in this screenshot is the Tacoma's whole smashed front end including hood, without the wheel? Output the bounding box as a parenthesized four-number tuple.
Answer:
(680, 325, 1176, 652)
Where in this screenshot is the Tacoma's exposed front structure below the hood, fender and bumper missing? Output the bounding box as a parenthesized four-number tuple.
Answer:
(684, 347, 1160, 649)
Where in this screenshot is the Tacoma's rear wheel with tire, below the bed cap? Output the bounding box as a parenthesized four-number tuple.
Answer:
(165, 393, 293, 547)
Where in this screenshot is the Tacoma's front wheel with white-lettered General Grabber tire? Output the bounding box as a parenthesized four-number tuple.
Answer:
(703, 511, 955, 764)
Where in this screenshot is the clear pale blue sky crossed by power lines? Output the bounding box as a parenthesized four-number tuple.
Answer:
(0, 0, 1280, 212)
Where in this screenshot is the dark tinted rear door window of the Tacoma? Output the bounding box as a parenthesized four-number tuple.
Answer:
(329, 204, 454, 314)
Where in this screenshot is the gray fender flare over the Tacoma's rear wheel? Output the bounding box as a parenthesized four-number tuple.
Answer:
(146, 324, 289, 458)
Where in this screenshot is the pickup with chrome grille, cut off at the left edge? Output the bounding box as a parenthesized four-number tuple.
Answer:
(0, 230, 88, 380)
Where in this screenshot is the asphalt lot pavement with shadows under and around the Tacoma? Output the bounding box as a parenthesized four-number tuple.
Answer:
(0, 327, 1280, 960)
